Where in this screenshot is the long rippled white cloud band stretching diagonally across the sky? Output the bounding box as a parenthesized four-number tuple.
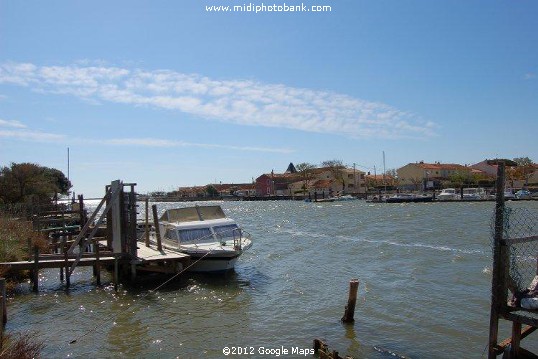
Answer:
(0, 62, 435, 138)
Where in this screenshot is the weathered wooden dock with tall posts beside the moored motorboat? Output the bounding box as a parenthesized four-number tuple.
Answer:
(0, 180, 191, 291)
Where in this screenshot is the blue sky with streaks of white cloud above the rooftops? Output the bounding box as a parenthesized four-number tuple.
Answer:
(0, 0, 538, 198)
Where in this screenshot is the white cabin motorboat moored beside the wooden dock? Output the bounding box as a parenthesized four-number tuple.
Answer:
(153, 206, 252, 272)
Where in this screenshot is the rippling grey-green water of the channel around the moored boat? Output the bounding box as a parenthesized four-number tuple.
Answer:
(7, 201, 538, 358)
